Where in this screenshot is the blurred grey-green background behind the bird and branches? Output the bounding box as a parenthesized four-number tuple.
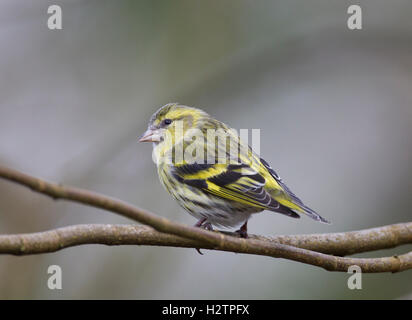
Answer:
(0, 0, 412, 299)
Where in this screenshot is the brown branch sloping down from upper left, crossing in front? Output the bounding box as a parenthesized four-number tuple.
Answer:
(0, 166, 412, 272)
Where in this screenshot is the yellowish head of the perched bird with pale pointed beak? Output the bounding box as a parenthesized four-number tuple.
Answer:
(139, 103, 208, 144)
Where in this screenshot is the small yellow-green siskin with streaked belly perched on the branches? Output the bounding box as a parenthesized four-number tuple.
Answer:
(139, 103, 328, 238)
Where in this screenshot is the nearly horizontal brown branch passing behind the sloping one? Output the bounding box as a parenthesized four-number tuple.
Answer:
(0, 222, 412, 256)
